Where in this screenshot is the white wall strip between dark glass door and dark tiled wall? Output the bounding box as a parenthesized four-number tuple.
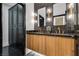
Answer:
(26, 3, 34, 30)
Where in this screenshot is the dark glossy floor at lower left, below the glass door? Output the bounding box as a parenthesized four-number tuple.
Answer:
(0, 46, 23, 56)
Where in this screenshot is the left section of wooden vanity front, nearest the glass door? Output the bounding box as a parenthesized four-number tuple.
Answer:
(27, 34, 46, 54)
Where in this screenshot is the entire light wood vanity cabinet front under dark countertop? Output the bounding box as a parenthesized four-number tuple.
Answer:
(27, 34, 76, 56)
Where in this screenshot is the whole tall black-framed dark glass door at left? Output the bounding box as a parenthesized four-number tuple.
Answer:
(9, 3, 25, 54)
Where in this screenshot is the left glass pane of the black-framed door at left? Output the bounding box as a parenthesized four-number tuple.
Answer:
(9, 6, 17, 45)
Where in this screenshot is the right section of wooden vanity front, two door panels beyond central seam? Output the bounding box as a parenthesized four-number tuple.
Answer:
(46, 36, 76, 56)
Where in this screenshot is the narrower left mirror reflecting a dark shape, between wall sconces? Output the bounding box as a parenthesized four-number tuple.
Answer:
(38, 7, 46, 27)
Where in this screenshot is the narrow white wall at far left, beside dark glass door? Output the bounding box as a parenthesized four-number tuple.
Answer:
(2, 3, 14, 47)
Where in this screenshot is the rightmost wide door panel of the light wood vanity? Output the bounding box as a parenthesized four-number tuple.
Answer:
(58, 37, 76, 56)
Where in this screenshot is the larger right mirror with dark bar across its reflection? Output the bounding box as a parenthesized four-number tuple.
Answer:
(53, 3, 66, 26)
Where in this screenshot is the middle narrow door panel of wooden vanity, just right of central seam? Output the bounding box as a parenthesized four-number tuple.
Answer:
(46, 36, 57, 56)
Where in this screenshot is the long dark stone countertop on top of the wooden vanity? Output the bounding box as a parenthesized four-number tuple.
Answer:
(27, 31, 75, 38)
